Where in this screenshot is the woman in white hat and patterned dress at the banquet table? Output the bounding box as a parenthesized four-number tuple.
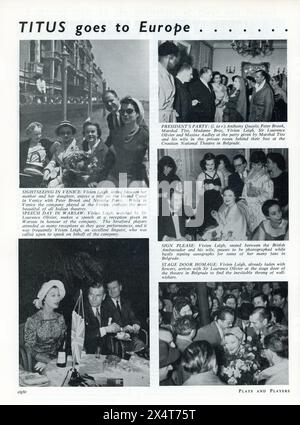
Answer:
(24, 280, 66, 371)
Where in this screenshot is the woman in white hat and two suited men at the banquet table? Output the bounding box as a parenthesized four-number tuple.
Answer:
(24, 278, 149, 372)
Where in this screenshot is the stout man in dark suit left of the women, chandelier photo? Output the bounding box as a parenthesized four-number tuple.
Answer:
(188, 66, 216, 122)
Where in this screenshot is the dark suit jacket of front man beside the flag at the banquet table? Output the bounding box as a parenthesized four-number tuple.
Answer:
(84, 301, 107, 354)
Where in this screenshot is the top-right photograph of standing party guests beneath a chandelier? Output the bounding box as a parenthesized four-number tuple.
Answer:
(158, 40, 287, 123)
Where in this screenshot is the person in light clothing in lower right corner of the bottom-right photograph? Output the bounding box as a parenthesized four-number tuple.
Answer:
(257, 325, 289, 385)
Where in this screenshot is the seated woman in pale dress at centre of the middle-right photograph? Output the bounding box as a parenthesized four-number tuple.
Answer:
(212, 187, 247, 241)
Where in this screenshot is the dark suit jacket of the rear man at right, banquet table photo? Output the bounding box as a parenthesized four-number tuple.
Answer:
(101, 296, 140, 327)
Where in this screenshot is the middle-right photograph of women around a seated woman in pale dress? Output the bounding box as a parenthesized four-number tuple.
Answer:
(158, 148, 289, 241)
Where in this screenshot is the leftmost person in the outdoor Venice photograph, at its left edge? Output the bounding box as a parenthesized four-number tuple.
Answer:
(20, 122, 51, 187)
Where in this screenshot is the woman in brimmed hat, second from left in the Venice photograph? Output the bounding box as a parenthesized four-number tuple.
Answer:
(44, 121, 79, 187)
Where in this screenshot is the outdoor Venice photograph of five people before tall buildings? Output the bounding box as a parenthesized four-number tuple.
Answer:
(19, 40, 149, 188)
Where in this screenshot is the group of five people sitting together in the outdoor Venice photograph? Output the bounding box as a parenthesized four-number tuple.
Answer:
(20, 90, 149, 188)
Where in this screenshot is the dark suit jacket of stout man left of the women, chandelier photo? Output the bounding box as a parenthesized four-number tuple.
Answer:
(188, 79, 216, 122)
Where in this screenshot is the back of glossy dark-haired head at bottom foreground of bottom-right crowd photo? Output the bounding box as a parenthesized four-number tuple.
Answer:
(181, 341, 222, 385)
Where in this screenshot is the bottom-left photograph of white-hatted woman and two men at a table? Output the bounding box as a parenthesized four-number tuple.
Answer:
(19, 239, 150, 387)
